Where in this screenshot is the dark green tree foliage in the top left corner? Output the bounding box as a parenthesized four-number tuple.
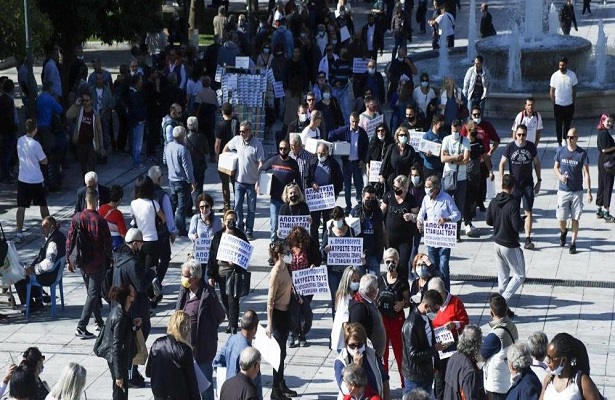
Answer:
(0, 0, 53, 60)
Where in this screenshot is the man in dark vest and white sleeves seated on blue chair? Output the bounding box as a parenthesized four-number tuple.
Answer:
(15, 216, 66, 310)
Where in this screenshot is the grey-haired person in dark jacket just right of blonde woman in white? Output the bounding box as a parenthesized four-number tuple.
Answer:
(348, 274, 386, 358)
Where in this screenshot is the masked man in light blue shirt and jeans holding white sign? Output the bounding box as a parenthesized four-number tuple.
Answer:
(416, 175, 461, 292)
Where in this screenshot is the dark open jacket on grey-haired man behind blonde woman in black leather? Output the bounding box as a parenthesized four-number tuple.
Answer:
(175, 279, 226, 364)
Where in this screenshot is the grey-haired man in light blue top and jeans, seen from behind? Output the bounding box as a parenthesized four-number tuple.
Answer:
(162, 126, 195, 236)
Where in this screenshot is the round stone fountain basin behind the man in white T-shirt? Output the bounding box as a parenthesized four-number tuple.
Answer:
(476, 34, 592, 84)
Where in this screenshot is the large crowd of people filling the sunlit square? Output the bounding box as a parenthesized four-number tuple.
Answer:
(0, 0, 615, 400)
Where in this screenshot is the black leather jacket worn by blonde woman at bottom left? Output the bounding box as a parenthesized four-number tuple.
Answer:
(145, 335, 201, 400)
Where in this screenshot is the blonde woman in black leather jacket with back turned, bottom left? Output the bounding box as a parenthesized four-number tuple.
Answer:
(145, 310, 201, 400)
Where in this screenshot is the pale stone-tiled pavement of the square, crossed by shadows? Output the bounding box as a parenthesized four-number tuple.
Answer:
(0, 1, 615, 400)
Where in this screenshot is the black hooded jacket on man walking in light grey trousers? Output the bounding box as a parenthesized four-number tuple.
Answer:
(486, 192, 523, 249)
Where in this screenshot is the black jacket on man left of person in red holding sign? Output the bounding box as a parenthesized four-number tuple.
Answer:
(402, 307, 439, 383)
